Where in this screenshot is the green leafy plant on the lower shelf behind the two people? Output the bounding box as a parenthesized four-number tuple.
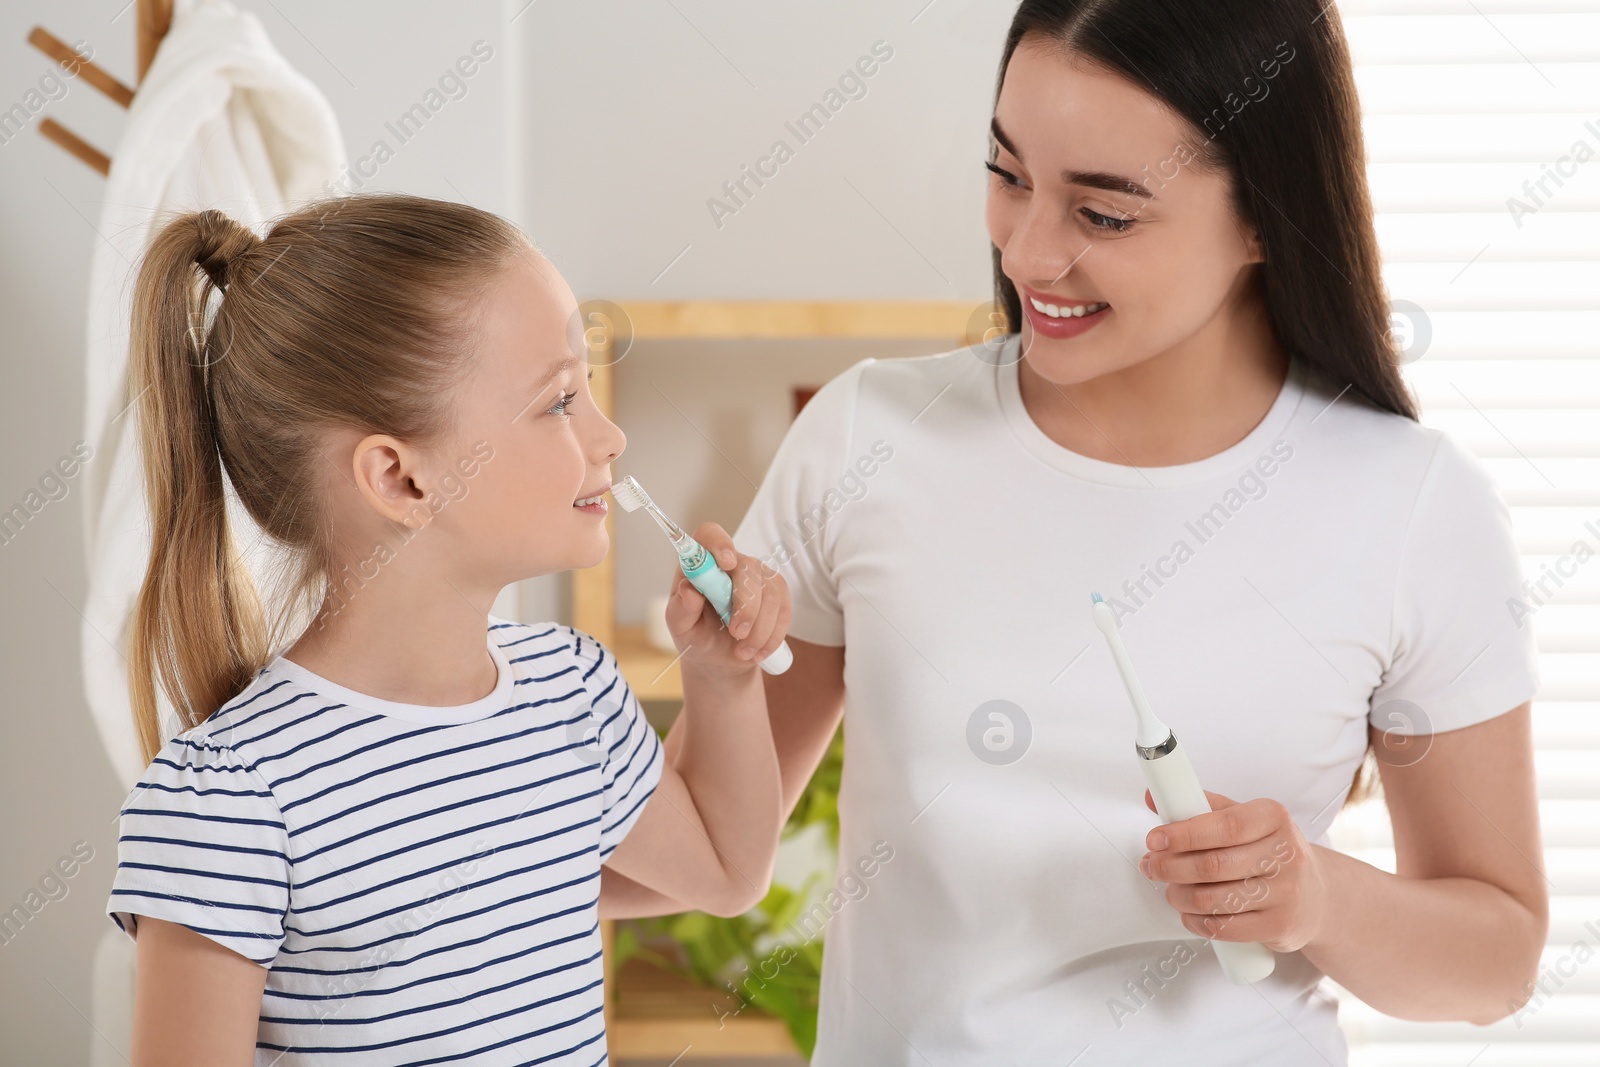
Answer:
(613, 729, 845, 1057)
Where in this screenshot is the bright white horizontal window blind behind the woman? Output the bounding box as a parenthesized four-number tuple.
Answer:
(1333, 0, 1600, 1067)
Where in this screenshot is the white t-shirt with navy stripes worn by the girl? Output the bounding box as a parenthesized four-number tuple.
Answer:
(106, 614, 662, 1067)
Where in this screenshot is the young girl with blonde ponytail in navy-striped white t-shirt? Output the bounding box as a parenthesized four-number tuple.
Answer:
(107, 195, 789, 1067)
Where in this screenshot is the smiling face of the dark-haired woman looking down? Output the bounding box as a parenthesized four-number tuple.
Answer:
(987, 38, 1259, 386)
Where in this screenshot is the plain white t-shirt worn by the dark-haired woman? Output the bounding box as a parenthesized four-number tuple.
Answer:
(734, 338, 1538, 1067)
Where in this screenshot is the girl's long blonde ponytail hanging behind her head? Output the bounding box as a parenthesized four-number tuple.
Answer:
(128, 211, 267, 763)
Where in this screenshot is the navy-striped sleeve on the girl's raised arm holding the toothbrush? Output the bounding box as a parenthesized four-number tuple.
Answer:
(574, 630, 666, 862)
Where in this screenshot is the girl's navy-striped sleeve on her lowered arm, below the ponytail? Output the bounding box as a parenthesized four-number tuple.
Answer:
(106, 728, 290, 966)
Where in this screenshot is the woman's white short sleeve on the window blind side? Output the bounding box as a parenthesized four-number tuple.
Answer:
(1368, 432, 1539, 734)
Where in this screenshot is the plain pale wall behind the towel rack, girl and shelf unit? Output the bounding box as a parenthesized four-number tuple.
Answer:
(0, 0, 1010, 1064)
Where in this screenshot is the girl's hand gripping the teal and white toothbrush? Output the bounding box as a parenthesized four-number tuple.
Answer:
(667, 523, 790, 675)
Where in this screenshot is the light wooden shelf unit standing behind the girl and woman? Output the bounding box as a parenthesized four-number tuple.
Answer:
(571, 301, 987, 1062)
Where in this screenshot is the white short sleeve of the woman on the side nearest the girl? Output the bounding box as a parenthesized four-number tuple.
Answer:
(733, 358, 874, 645)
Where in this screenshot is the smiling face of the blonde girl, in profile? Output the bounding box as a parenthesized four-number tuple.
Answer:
(434, 251, 627, 584)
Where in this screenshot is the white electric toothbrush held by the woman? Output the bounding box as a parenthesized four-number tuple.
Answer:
(1093, 593, 1277, 985)
